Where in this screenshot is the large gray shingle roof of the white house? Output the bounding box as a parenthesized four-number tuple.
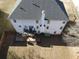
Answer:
(10, 0, 68, 20)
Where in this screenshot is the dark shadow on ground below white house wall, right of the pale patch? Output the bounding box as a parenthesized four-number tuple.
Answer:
(36, 35, 67, 47)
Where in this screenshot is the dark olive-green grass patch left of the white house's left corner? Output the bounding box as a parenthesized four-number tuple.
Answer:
(0, 11, 13, 37)
